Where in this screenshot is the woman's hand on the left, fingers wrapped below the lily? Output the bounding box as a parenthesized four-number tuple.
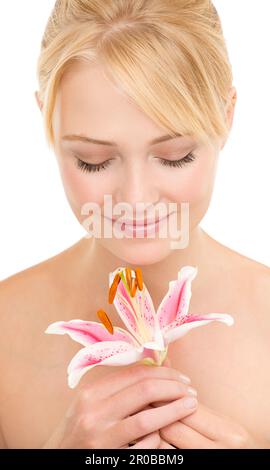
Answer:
(43, 364, 198, 449)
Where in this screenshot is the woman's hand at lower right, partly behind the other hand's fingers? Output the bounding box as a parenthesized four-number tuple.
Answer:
(151, 358, 264, 449)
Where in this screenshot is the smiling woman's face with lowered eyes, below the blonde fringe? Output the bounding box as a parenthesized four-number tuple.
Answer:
(49, 63, 234, 265)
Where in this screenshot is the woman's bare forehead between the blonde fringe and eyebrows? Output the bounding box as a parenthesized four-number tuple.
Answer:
(54, 63, 169, 141)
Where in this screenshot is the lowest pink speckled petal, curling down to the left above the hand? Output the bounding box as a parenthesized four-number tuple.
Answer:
(67, 341, 143, 388)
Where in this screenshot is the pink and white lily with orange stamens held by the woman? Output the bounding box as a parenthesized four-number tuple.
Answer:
(45, 266, 234, 388)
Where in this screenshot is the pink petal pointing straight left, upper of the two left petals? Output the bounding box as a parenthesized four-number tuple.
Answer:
(45, 319, 138, 346)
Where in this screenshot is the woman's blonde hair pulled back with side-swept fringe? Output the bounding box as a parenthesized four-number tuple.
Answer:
(37, 0, 233, 149)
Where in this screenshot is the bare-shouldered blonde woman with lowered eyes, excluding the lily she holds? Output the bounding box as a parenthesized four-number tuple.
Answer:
(0, 0, 270, 448)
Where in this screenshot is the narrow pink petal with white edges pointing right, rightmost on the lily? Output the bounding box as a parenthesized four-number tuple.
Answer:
(163, 313, 234, 345)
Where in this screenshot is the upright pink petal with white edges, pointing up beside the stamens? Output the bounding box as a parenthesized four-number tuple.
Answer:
(157, 266, 198, 329)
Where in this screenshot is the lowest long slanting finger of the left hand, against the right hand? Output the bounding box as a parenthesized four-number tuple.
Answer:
(107, 397, 197, 448)
